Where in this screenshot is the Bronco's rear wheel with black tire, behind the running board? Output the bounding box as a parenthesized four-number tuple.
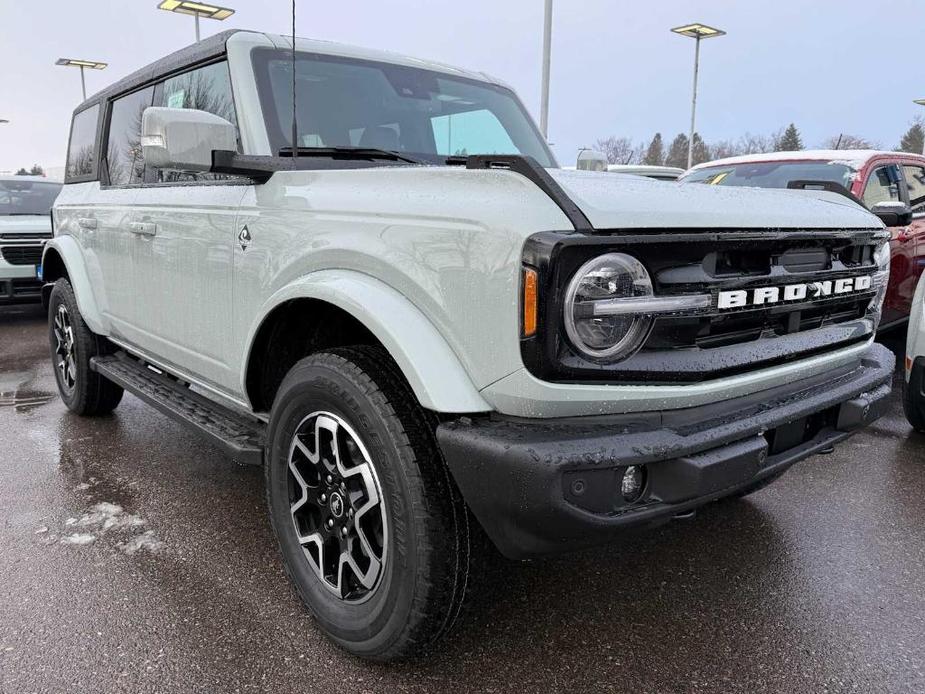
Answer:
(48, 278, 123, 416)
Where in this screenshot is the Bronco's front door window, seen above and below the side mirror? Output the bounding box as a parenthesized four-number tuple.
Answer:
(145, 61, 241, 183)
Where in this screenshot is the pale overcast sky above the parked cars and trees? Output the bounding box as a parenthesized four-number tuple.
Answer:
(0, 0, 925, 170)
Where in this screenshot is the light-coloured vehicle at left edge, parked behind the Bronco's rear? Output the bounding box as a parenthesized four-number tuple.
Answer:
(0, 176, 61, 305)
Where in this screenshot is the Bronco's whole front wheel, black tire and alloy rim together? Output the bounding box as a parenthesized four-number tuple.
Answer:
(266, 347, 469, 660)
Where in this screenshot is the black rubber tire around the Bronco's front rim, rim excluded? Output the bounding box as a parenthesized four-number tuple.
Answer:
(266, 346, 470, 661)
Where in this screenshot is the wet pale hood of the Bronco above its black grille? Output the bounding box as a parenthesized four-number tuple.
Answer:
(549, 169, 883, 229)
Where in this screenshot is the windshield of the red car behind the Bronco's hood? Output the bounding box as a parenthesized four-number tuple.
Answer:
(681, 161, 856, 191)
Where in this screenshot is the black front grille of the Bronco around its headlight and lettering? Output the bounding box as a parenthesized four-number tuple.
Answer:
(521, 230, 883, 384)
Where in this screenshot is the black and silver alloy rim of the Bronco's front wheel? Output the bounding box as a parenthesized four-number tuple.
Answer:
(287, 412, 389, 603)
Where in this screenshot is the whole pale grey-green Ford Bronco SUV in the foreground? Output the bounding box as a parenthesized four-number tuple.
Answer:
(43, 31, 894, 660)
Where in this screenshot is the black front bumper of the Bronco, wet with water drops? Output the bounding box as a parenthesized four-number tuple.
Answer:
(437, 344, 895, 559)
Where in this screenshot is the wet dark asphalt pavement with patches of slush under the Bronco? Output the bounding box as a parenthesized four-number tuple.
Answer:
(0, 308, 925, 694)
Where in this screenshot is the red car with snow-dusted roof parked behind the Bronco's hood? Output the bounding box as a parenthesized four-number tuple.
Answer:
(680, 150, 925, 327)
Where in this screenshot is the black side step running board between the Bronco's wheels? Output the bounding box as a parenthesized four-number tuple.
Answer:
(90, 352, 266, 465)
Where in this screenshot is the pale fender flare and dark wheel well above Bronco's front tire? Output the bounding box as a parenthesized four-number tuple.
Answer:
(241, 270, 491, 413)
